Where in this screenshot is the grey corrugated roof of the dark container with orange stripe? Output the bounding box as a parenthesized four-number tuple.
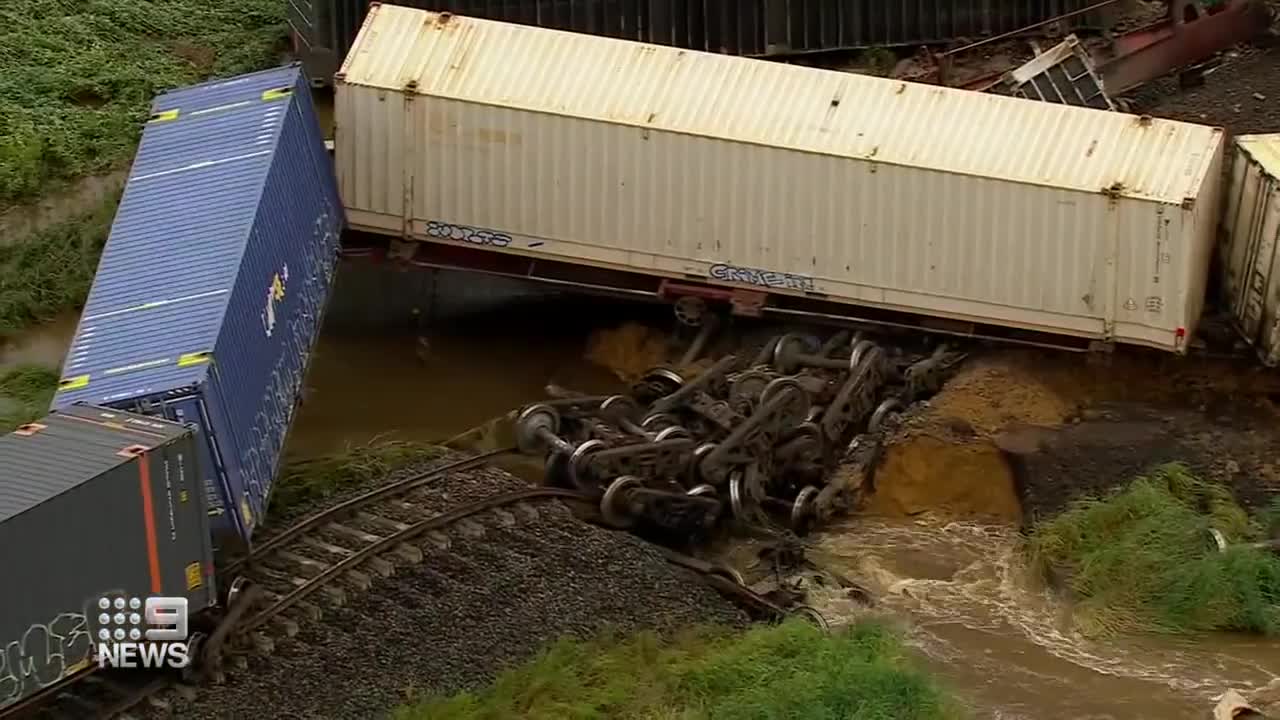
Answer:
(0, 405, 188, 523)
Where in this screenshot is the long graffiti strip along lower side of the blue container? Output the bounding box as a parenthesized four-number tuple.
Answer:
(236, 203, 338, 528)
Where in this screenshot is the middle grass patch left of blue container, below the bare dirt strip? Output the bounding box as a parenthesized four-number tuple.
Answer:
(0, 193, 119, 340)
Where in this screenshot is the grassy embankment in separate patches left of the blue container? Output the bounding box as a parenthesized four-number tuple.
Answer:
(0, 0, 284, 422)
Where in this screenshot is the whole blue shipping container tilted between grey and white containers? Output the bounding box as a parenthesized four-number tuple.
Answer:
(52, 64, 346, 543)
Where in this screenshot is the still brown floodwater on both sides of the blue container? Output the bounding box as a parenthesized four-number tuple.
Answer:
(0, 261, 629, 457)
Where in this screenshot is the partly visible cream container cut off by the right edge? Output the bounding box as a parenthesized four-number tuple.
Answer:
(1222, 133, 1280, 366)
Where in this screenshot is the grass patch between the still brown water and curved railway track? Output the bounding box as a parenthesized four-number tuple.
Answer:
(271, 441, 444, 512)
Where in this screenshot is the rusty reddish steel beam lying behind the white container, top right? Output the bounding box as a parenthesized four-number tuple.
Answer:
(1098, 0, 1271, 97)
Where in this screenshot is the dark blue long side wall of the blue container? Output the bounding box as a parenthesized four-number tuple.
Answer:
(209, 65, 344, 529)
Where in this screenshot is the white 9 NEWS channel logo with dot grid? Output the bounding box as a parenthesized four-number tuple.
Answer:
(93, 597, 191, 670)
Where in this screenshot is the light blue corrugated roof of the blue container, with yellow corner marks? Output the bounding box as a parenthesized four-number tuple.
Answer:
(54, 65, 301, 407)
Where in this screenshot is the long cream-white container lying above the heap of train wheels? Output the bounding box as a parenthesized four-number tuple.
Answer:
(335, 5, 1224, 352)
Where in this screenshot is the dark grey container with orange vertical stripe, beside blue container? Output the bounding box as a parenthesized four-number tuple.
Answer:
(0, 405, 218, 708)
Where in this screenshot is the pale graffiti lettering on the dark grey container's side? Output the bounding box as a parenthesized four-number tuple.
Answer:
(0, 604, 93, 707)
